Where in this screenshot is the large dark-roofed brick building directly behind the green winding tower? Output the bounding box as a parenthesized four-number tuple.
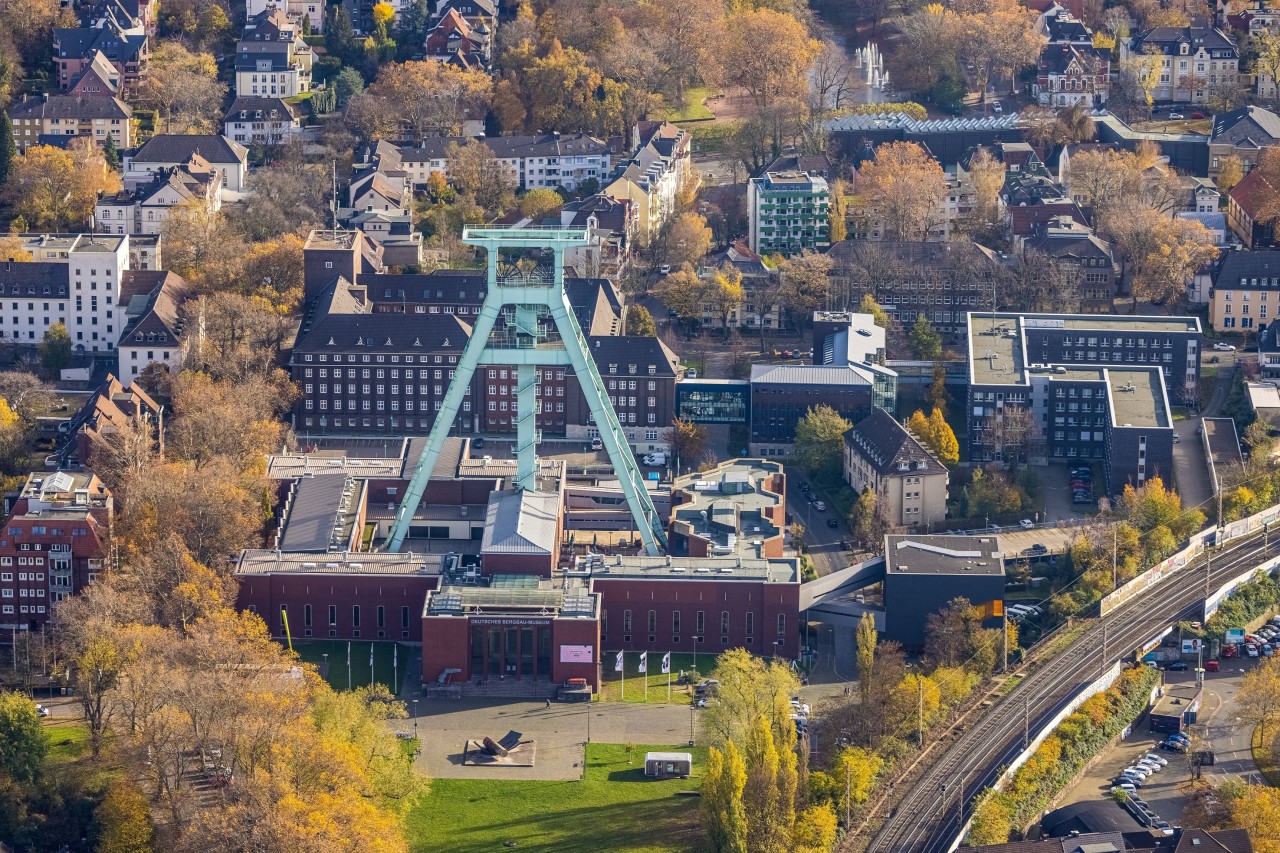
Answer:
(289, 232, 680, 452)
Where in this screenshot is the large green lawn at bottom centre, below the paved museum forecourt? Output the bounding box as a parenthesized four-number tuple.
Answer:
(407, 743, 707, 853)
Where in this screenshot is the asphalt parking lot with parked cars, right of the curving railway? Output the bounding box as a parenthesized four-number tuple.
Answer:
(1057, 658, 1262, 830)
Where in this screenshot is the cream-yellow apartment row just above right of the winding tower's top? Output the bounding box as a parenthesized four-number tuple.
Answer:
(604, 122, 694, 240)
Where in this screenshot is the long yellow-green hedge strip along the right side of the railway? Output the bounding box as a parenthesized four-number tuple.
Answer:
(967, 666, 1160, 829)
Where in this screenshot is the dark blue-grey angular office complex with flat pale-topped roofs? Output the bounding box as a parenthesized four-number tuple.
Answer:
(965, 313, 1199, 494)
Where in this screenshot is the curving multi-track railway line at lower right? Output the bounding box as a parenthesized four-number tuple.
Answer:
(867, 532, 1277, 853)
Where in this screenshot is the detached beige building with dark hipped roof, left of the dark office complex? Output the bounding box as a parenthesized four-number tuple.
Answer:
(844, 406, 950, 526)
